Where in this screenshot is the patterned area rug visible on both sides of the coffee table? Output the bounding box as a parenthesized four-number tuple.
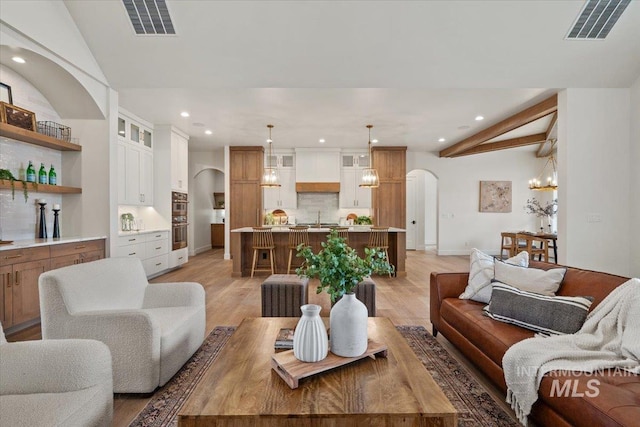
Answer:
(130, 326, 519, 427)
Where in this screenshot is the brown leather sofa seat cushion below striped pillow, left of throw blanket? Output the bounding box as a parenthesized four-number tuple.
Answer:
(440, 298, 534, 366)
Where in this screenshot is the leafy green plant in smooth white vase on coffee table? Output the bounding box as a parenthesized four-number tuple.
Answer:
(296, 230, 394, 357)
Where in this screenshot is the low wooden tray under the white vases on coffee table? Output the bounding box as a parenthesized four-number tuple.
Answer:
(271, 341, 387, 389)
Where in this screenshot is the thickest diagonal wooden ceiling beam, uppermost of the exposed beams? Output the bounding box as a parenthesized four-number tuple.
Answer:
(440, 95, 558, 157)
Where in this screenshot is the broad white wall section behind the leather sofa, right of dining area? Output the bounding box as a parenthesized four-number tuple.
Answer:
(558, 89, 638, 276)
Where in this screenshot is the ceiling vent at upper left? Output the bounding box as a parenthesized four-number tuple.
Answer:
(122, 0, 176, 35)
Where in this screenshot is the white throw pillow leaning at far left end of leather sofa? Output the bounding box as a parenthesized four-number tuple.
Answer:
(460, 248, 529, 304)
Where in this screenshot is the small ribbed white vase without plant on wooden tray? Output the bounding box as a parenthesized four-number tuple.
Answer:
(293, 304, 329, 362)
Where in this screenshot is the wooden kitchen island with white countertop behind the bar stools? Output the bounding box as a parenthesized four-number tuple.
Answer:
(231, 226, 407, 277)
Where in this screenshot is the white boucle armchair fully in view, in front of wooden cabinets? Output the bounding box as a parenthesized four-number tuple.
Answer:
(39, 258, 206, 393)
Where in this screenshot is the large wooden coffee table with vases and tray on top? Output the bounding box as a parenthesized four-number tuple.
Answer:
(178, 317, 457, 427)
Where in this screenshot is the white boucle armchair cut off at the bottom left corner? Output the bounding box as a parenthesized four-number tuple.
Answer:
(0, 325, 113, 427)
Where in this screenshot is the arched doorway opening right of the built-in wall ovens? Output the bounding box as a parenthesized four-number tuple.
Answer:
(189, 167, 226, 254)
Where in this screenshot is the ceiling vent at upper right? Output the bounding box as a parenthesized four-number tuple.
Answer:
(567, 0, 631, 40)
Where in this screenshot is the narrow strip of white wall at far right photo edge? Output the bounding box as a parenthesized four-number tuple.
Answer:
(629, 77, 640, 277)
